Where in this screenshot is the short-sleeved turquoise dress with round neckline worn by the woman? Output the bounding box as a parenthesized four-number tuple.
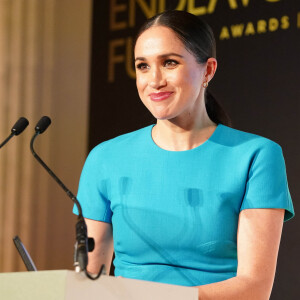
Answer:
(74, 124, 294, 286)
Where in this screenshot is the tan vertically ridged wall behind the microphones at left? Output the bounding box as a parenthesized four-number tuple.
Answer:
(0, 0, 92, 272)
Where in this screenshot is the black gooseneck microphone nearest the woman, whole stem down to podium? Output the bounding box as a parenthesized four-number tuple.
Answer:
(30, 116, 104, 280)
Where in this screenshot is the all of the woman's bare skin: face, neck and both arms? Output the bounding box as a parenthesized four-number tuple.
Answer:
(86, 26, 284, 300)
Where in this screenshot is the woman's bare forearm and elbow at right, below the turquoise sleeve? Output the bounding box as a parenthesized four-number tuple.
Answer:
(198, 209, 284, 300)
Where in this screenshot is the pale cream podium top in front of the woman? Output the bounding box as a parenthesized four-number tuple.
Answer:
(0, 270, 198, 300)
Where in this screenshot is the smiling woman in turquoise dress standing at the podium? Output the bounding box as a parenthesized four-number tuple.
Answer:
(74, 11, 294, 300)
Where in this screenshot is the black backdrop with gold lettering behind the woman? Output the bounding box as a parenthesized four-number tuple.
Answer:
(89, 0, 300, 300)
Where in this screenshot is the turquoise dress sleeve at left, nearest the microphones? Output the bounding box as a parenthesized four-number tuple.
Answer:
(73, 144, 112, 223)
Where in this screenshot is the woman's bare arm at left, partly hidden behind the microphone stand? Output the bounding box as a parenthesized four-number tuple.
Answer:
(85, 219, 114, 274)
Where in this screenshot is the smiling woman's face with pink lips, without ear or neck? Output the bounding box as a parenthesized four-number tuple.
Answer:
(135, 26, 206, 120)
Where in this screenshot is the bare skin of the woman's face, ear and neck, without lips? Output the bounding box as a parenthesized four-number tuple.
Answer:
(135, 26, 217, 151)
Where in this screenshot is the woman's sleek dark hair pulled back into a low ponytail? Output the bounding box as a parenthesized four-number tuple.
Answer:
(136, 10, 231, 126)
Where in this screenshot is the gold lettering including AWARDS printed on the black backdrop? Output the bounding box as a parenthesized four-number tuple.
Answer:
(107, 0, 300, 83)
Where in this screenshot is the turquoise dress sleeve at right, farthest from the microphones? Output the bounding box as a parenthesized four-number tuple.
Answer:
(240, 141, 295, 221)
